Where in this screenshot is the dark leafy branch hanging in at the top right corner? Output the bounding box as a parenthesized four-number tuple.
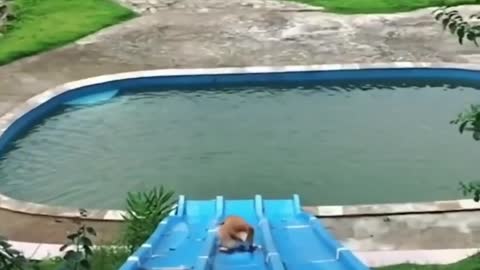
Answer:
(432, 7, 480, 47)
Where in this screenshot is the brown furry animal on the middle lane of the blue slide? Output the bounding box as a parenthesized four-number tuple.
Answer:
(218, 216, 255, 252)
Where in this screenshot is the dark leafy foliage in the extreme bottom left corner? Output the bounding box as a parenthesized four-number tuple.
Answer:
(0, 237, 38, 270)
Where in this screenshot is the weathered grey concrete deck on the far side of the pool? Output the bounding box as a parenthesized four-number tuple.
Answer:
(0, 6, 480, 116)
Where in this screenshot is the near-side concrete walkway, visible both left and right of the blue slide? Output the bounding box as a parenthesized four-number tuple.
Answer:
(0, 210, 480, 251)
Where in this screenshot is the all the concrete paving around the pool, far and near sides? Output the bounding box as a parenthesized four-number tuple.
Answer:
(0, 0, 480, 251)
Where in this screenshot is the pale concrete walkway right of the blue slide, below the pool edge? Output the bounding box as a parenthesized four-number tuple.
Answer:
(322, 212, 480, 251)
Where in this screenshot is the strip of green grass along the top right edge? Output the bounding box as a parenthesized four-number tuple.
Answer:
(295, 0, 480, 14)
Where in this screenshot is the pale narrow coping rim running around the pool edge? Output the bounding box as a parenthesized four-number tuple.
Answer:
(0, 62, 480, 221)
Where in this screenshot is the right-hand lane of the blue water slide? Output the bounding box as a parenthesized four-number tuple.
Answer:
(264, 195, 368, 270)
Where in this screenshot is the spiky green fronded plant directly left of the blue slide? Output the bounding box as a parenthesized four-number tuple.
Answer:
(123, 187, 175, 252)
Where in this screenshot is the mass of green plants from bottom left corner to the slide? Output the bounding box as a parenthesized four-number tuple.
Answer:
(0, 187, 175, 270)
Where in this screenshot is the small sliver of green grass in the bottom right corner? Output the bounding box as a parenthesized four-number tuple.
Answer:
(377, 255, 480, 270)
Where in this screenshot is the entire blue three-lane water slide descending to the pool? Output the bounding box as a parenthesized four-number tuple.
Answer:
(120, 195, 368, 270)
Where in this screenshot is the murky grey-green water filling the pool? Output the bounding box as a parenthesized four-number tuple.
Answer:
(0, 84, 480, 208)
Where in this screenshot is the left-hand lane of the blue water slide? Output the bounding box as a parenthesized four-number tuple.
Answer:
(120, 196, 223, 270)
